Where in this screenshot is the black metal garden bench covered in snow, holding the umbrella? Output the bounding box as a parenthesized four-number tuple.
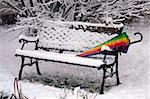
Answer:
(16, 20, 123, 94)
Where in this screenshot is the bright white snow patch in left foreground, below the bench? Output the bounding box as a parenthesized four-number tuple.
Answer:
(20, 82, 64, 99)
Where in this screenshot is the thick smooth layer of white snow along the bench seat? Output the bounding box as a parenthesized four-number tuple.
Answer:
(16, 49, 104, 67)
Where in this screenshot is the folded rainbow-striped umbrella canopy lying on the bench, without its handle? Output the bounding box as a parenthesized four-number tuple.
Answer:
(77, 32, 130, 57)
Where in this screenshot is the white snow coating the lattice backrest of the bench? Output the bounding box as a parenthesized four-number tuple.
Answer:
(38, 20, 122, 51)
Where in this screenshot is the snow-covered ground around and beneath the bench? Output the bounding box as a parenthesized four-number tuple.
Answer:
(0, 24, 150, 99)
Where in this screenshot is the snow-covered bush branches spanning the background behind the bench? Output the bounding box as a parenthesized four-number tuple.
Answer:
(1, 0, 150, 23)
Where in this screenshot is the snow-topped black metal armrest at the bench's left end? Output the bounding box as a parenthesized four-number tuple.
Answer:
(19, 35, 39, 50)
